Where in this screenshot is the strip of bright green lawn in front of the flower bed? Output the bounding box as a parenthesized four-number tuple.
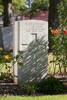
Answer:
(0, 95, 67, 100)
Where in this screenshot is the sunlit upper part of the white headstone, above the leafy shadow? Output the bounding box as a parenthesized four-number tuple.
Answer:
(15, 20, 48, 50)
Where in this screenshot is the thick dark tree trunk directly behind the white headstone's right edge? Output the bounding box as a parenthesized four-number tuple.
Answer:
(48, 0, 61, 50)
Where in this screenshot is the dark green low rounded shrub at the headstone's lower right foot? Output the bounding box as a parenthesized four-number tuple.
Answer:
(38, 77, 66, 94)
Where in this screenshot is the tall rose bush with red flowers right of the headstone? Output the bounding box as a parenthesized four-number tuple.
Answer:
(50, 25, 67, 73)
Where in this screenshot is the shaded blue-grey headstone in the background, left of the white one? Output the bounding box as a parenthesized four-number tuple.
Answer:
(2, 26, 13, 51)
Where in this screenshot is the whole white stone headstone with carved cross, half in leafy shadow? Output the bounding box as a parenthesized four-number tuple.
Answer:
(14, 20, 48, 83)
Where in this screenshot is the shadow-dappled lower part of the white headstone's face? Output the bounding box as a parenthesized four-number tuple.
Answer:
(18, 38, 48, 82)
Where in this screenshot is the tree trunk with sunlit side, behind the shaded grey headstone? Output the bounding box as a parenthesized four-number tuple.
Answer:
(3, 0, 12, 27)
